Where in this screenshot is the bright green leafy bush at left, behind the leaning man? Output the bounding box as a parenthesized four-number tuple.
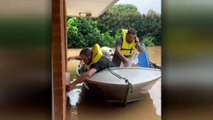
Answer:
(67, 18, 102, 48)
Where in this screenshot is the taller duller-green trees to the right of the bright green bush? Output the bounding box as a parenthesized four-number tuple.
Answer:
(97, 4, 161, 45)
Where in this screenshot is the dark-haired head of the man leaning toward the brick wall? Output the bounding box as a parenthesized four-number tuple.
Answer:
(80, 48, 92, 65)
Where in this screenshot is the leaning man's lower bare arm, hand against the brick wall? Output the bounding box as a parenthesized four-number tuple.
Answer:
(66, 68, 97, 91)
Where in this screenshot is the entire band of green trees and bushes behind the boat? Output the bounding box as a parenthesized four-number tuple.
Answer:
(67, 4, 161, 48)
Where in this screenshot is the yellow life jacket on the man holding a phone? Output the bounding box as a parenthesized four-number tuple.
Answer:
(121, 29, 136, 56)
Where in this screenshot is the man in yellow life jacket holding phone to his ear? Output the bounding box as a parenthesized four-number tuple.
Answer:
(112, 28, 143, 67)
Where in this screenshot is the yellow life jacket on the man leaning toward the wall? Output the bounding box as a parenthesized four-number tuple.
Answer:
(85, 44, 102, 70)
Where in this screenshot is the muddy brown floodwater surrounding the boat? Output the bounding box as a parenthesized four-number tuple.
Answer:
(66, 46, 161, 120)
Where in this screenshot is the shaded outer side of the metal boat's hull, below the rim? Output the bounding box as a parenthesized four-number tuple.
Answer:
(86, 79, 157, 103)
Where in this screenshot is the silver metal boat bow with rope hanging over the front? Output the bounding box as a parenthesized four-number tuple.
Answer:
(77, 67, 161, 103)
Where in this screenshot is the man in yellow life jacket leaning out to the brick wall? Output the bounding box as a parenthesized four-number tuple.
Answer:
(66, 44, 113, 91)
